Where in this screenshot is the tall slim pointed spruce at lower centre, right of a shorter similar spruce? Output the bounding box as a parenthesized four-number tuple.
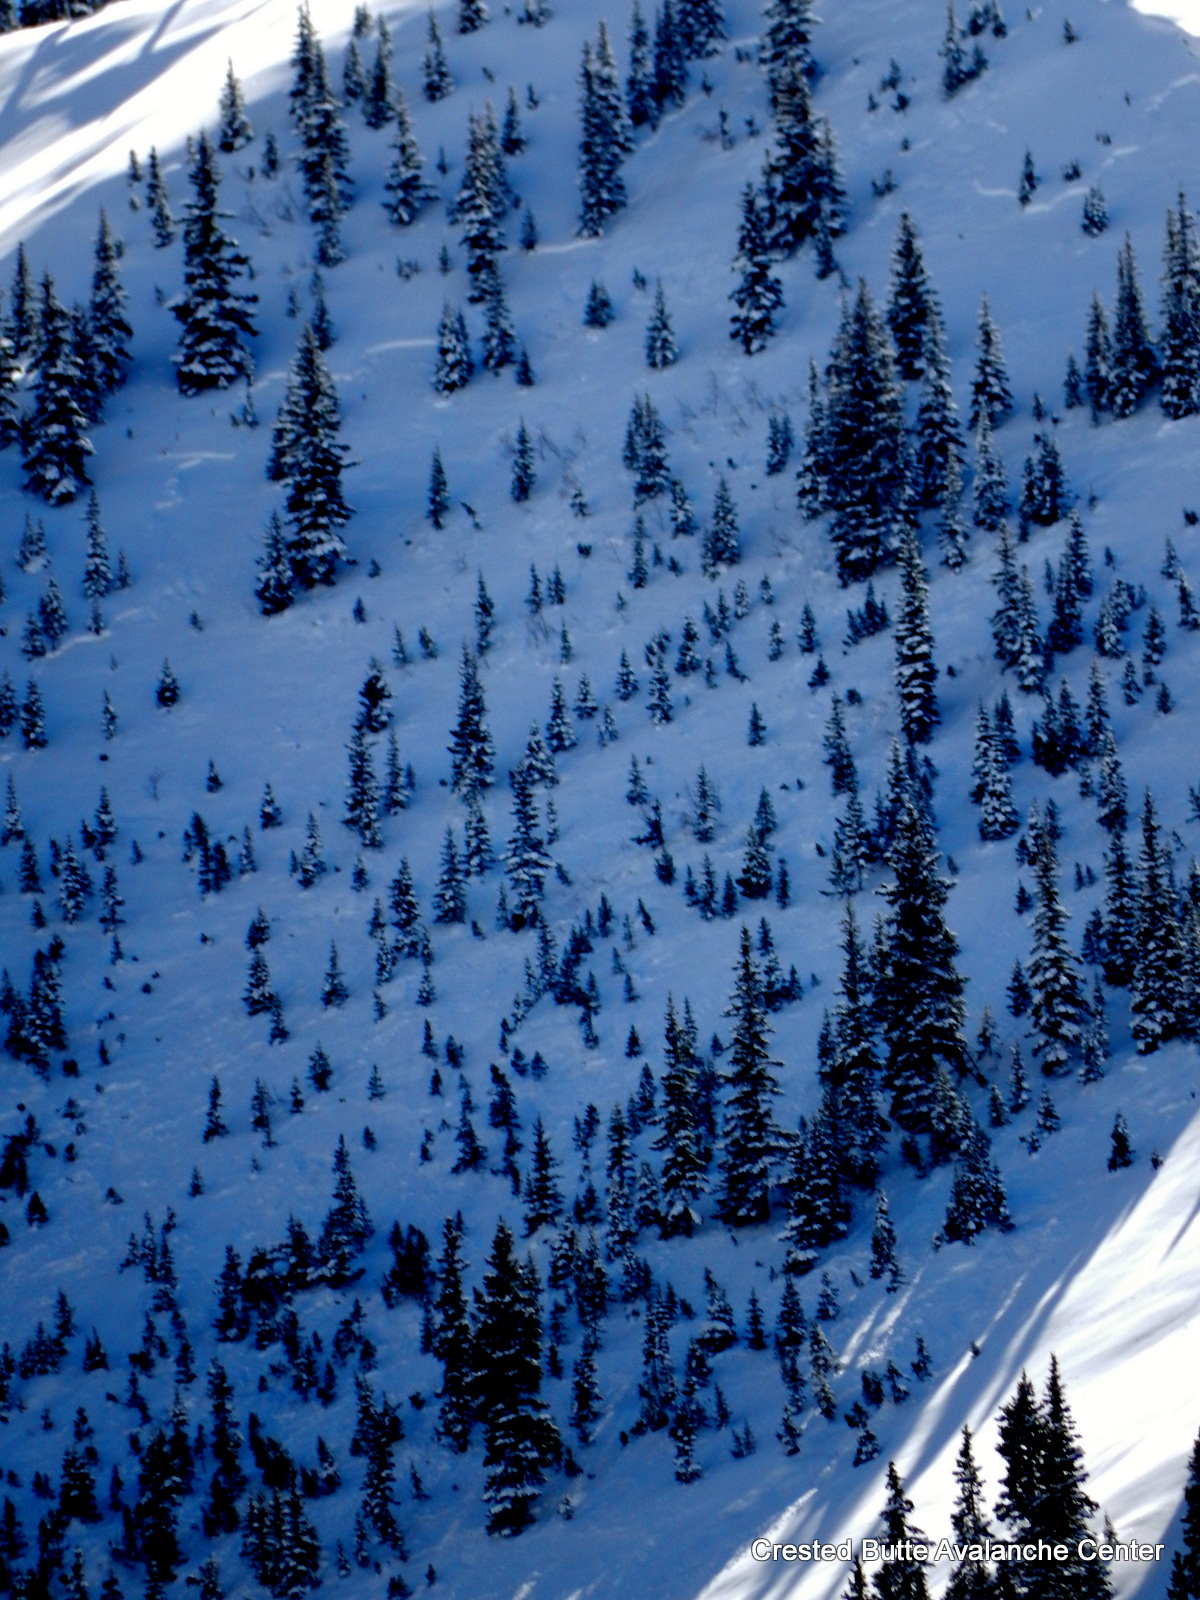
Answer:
(718, 923, 779, 1227)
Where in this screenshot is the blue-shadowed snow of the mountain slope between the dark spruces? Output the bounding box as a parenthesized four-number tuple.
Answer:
(0, 3, 1200, 1595)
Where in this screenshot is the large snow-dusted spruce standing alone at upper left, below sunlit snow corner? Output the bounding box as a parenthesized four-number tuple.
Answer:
(171, 133, 258, 395)
